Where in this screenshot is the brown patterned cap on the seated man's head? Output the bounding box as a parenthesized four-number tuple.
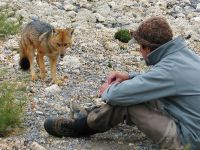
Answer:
(131, 16, 173, 51)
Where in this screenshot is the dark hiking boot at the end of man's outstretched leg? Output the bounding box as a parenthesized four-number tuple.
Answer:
(44, 116, 97, 137)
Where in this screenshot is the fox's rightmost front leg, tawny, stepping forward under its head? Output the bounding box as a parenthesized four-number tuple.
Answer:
(50, 57, 62, 84)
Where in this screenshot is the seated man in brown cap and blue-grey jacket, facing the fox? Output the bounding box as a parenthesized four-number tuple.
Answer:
(44, 17, 200, 150)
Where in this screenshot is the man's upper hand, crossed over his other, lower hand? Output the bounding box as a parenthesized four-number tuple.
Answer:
(107, 71, 129, 84)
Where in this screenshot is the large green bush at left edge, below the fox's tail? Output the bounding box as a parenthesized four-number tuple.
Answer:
(0, 71, 26, 137)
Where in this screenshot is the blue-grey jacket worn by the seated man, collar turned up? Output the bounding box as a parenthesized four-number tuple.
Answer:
(102, 37, 200, 149)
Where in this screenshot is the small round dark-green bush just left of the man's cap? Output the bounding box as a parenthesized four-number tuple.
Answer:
(115, 29, 131, 43)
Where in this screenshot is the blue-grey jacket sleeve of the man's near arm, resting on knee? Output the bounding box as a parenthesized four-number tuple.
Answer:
(102, 69, 176, 106)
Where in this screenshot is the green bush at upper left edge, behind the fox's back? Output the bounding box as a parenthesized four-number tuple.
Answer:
(0, 12, 22, 39)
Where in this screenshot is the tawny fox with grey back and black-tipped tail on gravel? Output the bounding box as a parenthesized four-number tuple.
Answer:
(19, 20, 74, 84)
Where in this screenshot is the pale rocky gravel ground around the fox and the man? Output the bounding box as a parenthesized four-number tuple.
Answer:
(0, 0, 200, 150)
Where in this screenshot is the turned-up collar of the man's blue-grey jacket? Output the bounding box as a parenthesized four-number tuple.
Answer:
(146, 37, 186, 65)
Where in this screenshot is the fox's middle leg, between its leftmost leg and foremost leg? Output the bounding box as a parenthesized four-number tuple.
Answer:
(37, 52, 45, 80)
